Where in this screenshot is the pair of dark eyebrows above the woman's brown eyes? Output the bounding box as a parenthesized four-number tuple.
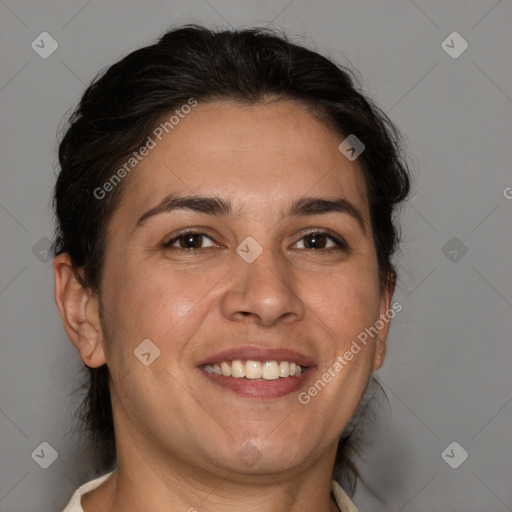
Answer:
(135, 194, 366, 233)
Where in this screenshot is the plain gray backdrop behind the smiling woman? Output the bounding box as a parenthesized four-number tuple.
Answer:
(0, 0, 512, 512)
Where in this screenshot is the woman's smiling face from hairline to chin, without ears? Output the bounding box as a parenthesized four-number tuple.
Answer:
(97, 102, 389, 474)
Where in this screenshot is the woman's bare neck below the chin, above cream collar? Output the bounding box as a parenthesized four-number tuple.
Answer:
(82, 434, 338, 512)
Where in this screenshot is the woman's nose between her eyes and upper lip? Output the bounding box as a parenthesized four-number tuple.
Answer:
(221, 250, 305, 327)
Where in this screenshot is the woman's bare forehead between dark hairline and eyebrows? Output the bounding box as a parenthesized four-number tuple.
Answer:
(114, 101, 368, 224)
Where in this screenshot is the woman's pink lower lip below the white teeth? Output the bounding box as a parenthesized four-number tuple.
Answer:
(201, 368, 311, 398)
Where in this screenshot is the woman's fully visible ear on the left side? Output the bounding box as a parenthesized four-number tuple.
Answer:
(53, 253, 105, 368)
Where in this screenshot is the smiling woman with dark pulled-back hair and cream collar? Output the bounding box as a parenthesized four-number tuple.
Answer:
(54, 27, 409, 512)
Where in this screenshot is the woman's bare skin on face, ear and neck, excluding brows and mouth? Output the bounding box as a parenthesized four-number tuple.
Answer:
(54, 101, 393, 512)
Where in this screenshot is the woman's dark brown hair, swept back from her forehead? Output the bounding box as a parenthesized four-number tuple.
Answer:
(54, 26, 409, 493)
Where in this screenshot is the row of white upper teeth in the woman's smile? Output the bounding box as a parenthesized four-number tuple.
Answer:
(203, 359, 304, 380)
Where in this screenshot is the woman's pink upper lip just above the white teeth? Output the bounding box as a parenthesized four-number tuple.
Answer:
(197, 346, 314, 367)
